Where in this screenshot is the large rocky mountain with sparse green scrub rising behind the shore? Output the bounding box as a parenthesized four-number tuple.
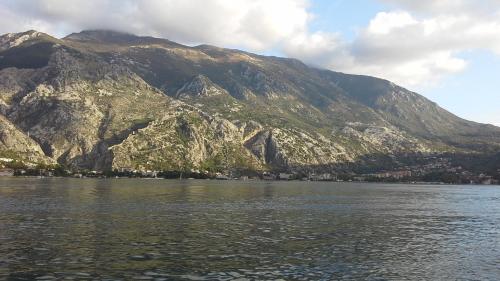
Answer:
(0, 30, 500, 171)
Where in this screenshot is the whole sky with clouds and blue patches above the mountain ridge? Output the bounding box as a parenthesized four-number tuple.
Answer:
(0, 0, 500, 126)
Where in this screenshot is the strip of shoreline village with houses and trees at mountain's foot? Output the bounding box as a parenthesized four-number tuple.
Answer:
(0, 153, 500, 185)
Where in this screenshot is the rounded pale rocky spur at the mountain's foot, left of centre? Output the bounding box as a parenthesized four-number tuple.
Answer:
(111, 111, 263, 170)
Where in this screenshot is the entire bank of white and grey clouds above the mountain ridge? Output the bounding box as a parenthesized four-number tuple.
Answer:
(0, 0, 500, 88)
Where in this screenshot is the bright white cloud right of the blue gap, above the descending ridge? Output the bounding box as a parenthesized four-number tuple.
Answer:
(286, 0, 500, 88)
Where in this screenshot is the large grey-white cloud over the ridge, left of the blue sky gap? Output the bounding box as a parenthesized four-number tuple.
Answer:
(0, 0, 310, 51)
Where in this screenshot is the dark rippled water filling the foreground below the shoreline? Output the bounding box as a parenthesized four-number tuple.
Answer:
(0, 179, 500, 280)
